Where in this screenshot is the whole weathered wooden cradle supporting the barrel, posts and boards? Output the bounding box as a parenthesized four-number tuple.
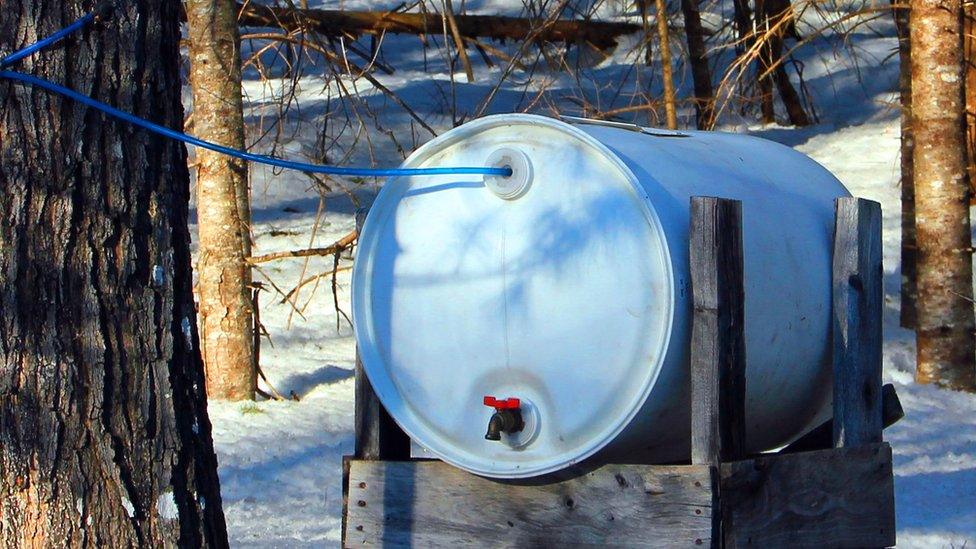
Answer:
(342, 197, 903, 547)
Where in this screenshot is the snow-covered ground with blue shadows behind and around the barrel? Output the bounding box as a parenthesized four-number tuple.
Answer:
(191, 0, 976, 548)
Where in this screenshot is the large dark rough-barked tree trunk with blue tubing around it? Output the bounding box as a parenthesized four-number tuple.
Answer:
(0, 0, 227, 547)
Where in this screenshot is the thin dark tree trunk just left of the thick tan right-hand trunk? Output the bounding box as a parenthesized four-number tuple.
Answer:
(891, 0, 916, 329)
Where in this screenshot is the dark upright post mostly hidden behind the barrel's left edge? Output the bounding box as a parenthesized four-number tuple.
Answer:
(354, 209, 410, 460)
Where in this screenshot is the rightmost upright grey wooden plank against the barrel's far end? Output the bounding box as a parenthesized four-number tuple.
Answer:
(832, 198, 884, 448)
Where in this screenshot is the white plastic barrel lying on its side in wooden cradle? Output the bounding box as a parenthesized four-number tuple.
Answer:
(353, 115, 848, 478)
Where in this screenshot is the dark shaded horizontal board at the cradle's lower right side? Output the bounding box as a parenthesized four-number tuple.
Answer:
(720, 443, 895, 548)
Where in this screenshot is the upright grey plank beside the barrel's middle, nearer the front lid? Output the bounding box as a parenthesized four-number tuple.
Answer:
(689, 196, 746, 465)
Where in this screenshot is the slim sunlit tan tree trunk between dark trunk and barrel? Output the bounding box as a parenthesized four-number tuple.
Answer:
(185, 0, 257, 400)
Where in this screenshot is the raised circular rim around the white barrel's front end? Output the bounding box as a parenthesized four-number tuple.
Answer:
(351, 114, 676, 479)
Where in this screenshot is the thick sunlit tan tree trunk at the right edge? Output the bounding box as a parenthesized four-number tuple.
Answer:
(911, 0, 976, 390)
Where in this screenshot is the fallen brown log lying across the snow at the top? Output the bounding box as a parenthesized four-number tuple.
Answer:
(238, 3, 641, 49)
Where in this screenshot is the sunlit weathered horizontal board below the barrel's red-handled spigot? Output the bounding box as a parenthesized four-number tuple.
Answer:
(344, 460, 712, 548)
